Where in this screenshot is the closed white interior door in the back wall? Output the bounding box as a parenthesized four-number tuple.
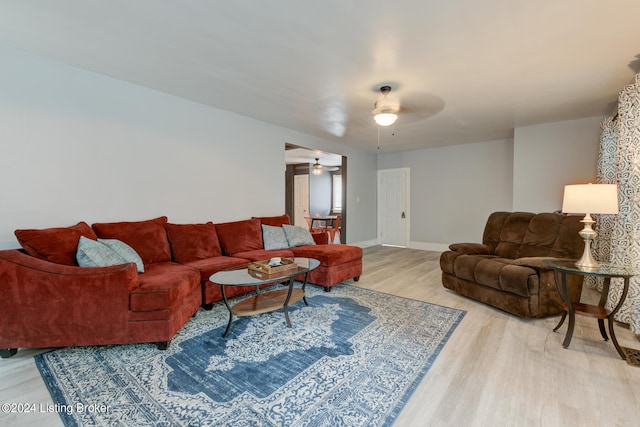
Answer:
(378, 169, 410, 247)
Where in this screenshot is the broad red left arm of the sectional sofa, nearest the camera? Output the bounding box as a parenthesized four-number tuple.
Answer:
(0, 250, 138, 348)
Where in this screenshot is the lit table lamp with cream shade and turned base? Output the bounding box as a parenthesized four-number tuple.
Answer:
(562, 184, 618, 269)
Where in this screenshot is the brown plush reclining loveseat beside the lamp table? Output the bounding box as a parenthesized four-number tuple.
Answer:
(440, 212, 584, 318)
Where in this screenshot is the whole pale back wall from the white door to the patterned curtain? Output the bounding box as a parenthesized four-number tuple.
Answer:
(378, 117, 602, 250)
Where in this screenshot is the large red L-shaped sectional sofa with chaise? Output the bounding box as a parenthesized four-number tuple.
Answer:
(0, 215, 362, 357)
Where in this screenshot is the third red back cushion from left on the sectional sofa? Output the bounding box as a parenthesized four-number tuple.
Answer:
(164, 222, 222, 264)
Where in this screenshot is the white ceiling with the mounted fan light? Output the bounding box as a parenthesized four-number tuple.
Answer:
(0, 0, 640, 151)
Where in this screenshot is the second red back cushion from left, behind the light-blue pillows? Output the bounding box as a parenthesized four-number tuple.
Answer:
(91, 216, 171, 265)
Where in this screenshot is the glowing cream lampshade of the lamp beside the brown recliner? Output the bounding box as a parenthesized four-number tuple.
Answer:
(562, 184, 618, 214)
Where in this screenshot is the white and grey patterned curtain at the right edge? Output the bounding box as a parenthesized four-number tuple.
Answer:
(596, 74, 640, 334)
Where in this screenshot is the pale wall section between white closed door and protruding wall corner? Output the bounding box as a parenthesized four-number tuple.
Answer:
(378, 140, 513, 250)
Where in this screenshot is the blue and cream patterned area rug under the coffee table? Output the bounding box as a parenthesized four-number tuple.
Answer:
(36, 285, 465, 426)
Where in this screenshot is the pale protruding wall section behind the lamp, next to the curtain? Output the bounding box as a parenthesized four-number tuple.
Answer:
(513, 117, 603, 212)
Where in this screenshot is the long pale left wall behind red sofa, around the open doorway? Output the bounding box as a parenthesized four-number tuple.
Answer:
(0, 47, 376, 248)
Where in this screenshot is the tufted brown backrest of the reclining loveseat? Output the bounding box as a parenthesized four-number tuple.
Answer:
(483, 212, 584, 259)
